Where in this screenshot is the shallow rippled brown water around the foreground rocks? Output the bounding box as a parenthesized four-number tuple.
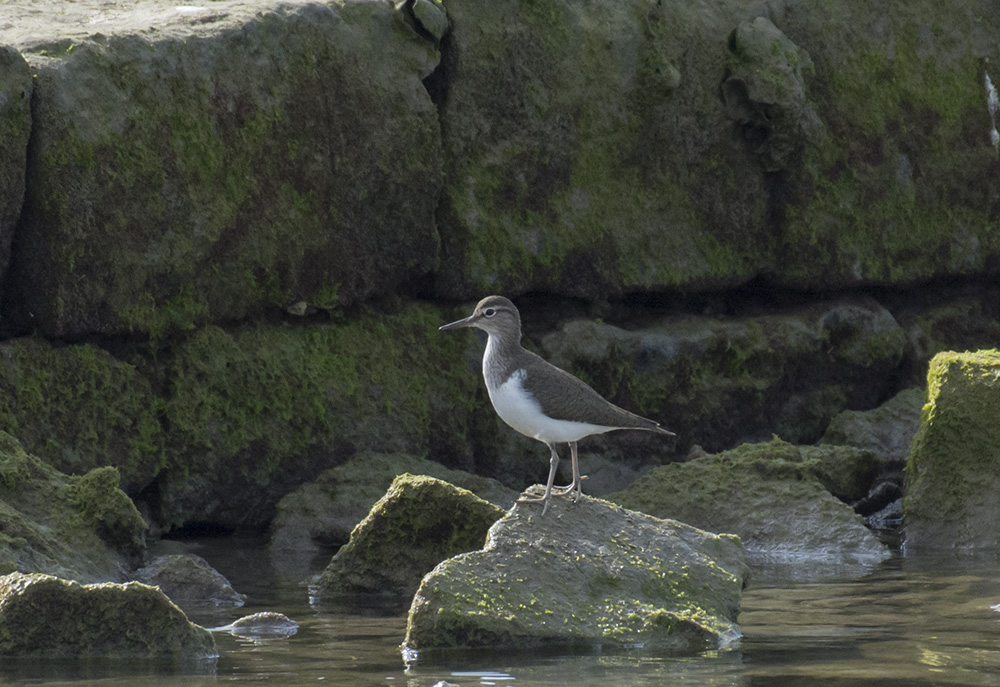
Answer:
(0, 538, 1000, 687)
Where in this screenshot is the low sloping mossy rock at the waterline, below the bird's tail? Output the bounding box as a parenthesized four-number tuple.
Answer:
(609, 439, 889, 563)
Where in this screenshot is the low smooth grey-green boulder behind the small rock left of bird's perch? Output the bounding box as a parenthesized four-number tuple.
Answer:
(270, 451, 518, 558)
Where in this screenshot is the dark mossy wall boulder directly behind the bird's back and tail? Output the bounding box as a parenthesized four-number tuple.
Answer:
(541, 298, 905, 451)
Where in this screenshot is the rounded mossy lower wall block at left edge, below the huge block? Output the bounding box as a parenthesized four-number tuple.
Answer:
(0, 338, 164, 494)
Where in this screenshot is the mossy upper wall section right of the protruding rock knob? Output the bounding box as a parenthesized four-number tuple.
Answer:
(773, 0, 1000, 288)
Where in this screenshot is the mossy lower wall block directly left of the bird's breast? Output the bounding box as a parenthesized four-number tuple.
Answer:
(152, 305, 485, 528)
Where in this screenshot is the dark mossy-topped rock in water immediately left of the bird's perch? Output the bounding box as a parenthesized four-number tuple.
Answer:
(314, 475, 505, 601)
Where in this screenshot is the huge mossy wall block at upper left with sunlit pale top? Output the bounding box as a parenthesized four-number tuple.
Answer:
(0, 0, 441, 337)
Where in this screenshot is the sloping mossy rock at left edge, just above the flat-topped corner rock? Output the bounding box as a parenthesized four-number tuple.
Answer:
(0, 432, 147, 581)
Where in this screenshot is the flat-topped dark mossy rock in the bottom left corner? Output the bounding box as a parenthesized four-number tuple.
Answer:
(0, 573, 217, 660)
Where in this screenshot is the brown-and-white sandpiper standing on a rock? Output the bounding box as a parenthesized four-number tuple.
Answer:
(438, 296, 676, 516)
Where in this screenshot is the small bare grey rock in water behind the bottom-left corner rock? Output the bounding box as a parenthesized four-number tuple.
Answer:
(133, 553, 247, 610)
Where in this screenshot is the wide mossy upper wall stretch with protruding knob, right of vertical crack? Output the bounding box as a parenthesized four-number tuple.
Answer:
(428, 0, 1000, 300)
